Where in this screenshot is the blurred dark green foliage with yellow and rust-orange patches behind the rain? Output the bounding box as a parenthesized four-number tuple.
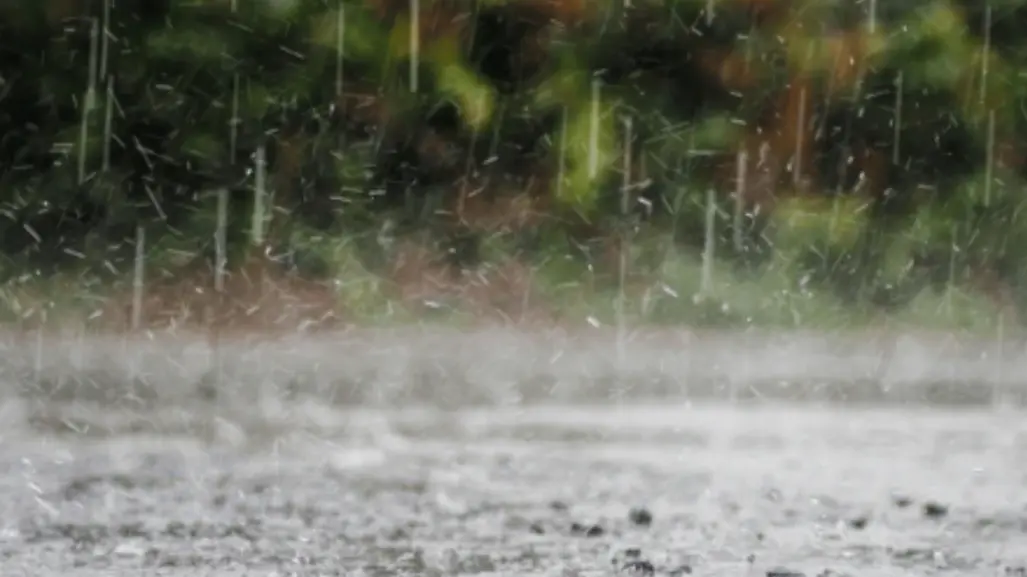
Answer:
(0, 0, 1027, 322)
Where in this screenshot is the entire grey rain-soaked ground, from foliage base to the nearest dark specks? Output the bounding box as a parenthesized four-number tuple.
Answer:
(0, 328, 1027, 577)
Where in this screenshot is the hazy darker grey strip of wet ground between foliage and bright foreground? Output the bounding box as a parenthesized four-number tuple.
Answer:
(6, 328, 1027, 409)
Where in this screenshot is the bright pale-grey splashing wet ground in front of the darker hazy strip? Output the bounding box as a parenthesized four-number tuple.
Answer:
(0, 406, 1027, 576)
